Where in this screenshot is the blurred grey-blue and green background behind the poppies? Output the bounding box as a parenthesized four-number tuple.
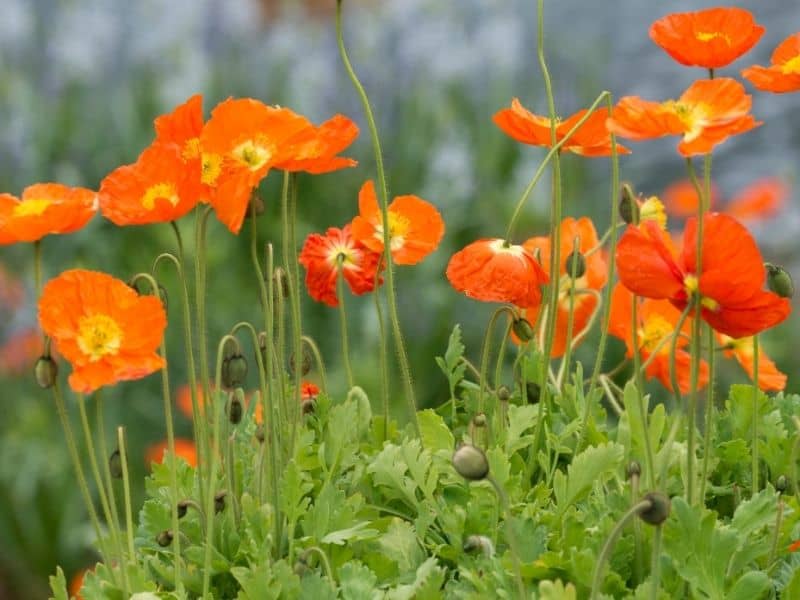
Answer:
(0, 0, 800, 599)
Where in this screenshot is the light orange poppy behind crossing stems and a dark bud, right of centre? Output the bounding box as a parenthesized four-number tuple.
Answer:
(522, 217, 608, 358)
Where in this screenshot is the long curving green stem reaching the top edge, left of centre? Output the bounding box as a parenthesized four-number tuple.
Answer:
(336, 0, 422, 440)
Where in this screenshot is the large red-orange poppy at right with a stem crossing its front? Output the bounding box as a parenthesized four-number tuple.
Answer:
(616, 213, 791, 338)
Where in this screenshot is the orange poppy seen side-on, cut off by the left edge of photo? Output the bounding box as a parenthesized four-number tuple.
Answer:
(0, 183, 97, 244)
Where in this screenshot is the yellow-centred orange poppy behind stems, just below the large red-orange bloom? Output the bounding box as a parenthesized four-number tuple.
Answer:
(608, 283, 708, 394)
